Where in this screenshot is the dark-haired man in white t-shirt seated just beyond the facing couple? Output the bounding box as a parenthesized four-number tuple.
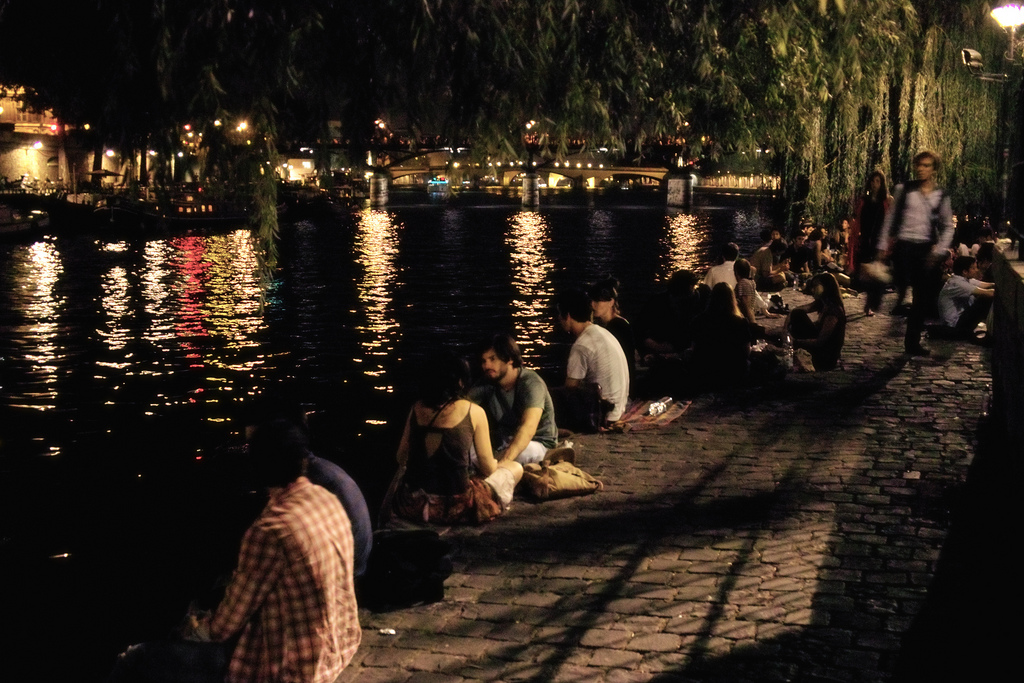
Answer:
(555, 290, 630, 429)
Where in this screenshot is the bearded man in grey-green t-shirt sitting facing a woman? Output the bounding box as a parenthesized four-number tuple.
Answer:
(469, 334, 558, 465)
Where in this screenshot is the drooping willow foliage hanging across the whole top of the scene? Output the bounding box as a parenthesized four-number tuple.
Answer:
(0, 0, 1001, 236)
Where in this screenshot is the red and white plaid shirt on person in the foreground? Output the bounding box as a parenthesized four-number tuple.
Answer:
(210, 477, 361, 683)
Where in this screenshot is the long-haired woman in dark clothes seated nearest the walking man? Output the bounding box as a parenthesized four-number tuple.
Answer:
(786, 272, 846, 370)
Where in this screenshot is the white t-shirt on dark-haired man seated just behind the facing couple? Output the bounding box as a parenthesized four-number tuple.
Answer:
(565, 324, 630, 422)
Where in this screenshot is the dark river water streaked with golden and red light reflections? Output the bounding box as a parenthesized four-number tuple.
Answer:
(0, 197, 764, 678)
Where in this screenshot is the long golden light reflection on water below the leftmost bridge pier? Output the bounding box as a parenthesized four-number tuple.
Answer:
(354, 210, 400, 391)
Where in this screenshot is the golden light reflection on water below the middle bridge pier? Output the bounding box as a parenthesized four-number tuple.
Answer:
(506, 211, 554, 358)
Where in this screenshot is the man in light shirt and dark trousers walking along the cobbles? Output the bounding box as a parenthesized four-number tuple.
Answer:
(879, 152, 953, 355)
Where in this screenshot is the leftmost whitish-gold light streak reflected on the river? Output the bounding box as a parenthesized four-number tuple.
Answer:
(15, 242, 63, 411)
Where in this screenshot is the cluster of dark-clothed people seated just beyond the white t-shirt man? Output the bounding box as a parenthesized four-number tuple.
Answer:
(637, 239, 846, 391)
